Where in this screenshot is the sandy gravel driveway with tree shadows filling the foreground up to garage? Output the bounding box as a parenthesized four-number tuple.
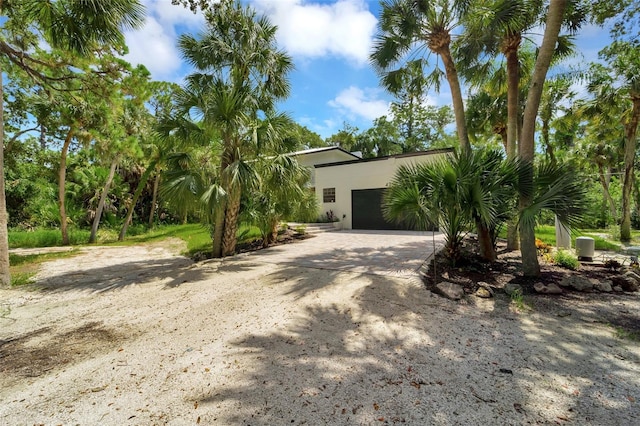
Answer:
(0, 232, 640, 425)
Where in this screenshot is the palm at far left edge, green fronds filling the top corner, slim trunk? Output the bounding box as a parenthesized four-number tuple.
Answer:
(0, 0, 144, 285)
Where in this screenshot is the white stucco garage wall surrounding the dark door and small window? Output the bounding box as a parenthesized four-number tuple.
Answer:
(315, 153, 447, 229)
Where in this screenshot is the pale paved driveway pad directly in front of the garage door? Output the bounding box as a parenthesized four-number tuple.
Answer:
(239, 230, 444, 276)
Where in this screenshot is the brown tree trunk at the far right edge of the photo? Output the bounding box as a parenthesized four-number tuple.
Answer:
(620, 94, 640, 241)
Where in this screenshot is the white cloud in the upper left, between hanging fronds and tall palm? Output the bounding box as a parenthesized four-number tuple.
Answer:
(124, 0, 204, 81)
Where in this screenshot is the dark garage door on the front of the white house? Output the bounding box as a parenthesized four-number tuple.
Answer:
(351, 188, 407, 230)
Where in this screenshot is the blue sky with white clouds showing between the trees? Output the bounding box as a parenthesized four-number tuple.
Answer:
(125, 0, 609, 138)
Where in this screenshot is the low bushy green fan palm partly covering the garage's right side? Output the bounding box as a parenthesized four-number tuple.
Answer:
(384, 149, 520, 261)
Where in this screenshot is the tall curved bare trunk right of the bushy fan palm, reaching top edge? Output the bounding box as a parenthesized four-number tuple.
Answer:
(518, 0, 567, 277)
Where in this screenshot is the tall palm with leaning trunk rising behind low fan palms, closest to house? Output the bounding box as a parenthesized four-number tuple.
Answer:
(370, 0, 470, 151)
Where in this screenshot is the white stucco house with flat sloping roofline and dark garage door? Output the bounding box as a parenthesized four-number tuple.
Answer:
(292, 147, 453, 230)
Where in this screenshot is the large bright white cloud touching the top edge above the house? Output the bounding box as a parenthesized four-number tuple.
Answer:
(254, 0, 377, 66)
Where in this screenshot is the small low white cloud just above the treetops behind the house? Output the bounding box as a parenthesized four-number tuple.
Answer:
(328, 86, 389, 120)
